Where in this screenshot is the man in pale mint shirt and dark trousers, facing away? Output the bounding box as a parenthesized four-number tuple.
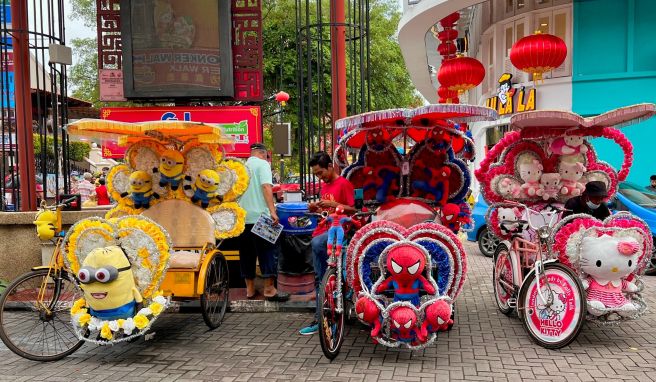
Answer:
(239, 143, 289, 301)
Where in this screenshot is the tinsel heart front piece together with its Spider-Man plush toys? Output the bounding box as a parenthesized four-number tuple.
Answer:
(347, 221, 466, 348)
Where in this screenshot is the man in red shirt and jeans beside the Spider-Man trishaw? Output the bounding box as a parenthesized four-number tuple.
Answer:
(299, 151, 355, 335)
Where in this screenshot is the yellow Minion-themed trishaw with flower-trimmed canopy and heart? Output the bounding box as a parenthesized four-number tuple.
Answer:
(0, 120, 248, 361)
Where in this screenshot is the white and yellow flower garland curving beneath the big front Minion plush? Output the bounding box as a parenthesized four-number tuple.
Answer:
(71, 291, 170, 345)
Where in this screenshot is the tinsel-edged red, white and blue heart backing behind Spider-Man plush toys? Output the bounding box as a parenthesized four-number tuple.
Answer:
(347, 220, 467, 299)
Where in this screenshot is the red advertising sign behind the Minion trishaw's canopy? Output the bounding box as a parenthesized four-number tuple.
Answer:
(100, 106, 263, 158)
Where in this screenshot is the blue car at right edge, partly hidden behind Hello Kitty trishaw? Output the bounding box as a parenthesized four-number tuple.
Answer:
(609, 182, 656, 275)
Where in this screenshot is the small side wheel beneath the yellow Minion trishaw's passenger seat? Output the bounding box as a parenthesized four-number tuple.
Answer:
(200, 252, 230, 330)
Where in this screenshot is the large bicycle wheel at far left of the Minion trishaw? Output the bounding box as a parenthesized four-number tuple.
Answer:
(0, 269, 84, 361)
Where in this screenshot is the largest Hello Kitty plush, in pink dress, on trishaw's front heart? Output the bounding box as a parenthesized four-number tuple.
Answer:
(580, 234, 641, 319)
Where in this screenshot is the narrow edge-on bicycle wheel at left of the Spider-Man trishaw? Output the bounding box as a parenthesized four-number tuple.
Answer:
(319, 267, 344, 360)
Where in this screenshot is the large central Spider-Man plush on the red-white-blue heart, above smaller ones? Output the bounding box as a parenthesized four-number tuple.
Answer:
(376, 244, 435, 306)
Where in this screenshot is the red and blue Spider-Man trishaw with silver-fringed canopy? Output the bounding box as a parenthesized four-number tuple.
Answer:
(312, 105, 497, 359)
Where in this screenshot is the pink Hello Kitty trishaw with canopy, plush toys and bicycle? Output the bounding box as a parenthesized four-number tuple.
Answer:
(475, 104, 656, 349)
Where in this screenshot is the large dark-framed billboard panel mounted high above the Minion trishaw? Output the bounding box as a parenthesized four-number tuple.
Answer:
(121, 0, 234, 99)
